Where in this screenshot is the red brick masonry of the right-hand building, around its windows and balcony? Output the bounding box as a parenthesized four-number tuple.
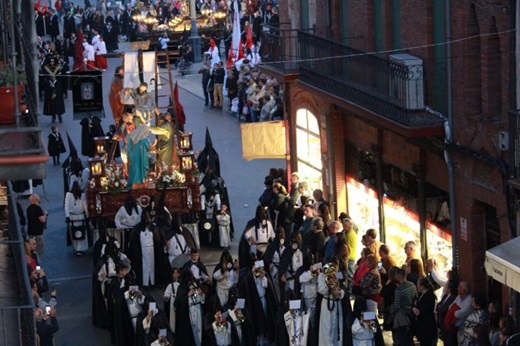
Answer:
(280, 0, 514, 294)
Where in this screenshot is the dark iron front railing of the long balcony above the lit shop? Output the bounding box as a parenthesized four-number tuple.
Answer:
(298, 32, 442, 127)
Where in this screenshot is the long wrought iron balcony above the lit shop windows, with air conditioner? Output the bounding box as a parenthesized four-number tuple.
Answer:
(260, 28, 443, 134)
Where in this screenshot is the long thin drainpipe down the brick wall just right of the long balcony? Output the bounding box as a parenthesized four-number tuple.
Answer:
(444, 0, 459, 278)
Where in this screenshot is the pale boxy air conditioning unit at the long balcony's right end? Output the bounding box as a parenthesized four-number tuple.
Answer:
(390, 54, 424, 110)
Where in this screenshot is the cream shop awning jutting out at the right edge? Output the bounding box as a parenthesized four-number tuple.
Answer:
(485, 237, 520, 292)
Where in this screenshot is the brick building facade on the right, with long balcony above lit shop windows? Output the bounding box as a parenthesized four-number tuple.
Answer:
(263, 0, 518, 303)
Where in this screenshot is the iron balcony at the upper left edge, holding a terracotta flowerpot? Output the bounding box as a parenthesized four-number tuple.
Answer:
(0, 0, 49, 181)
